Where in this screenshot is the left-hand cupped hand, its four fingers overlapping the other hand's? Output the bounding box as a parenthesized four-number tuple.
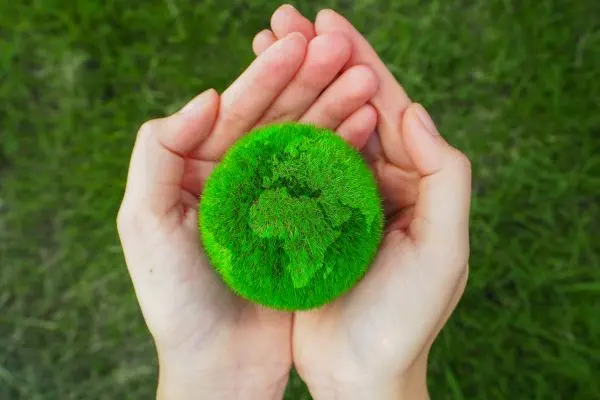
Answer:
(117, 29, 378, 400)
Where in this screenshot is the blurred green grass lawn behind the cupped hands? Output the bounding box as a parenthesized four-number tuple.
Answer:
(0, 0, 600, 399)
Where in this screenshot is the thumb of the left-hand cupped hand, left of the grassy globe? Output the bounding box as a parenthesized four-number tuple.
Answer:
(119, 89, 219, 216)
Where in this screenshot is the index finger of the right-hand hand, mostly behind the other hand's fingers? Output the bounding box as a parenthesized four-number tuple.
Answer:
(315, 10, 414, 169)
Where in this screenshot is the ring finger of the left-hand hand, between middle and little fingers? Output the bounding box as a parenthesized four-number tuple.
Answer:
(300, 65, 379, 130)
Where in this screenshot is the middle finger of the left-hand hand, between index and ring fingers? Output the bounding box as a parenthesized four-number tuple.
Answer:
(258, 33, 350, 125)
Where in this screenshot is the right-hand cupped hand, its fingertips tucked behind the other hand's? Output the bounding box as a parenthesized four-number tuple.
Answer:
(253, 5, 471, 399)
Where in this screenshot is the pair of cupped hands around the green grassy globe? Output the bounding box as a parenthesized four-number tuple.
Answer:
(117, 5, 471, 400)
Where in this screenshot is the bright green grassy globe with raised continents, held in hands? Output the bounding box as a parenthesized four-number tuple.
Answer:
(199, 123, 383, 310)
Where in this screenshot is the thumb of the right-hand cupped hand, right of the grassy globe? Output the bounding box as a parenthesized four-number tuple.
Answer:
(402, 103, 471, 265)
